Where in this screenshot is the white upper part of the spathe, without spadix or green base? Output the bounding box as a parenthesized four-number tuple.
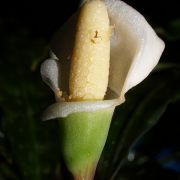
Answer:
(41, 0, 165, 120)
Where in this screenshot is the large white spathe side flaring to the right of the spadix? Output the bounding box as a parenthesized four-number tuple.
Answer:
(105, 0, 164, 99)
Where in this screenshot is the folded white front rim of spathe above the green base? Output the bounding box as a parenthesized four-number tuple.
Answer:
(42, 99, 119, 121)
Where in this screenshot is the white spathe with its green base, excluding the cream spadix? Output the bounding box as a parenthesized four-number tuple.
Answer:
(41, 0, 165, 179)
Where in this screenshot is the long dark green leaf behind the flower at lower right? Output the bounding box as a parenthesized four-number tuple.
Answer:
(96, 67, 180, 180)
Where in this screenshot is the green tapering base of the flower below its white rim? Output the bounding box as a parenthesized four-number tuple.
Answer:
(59, 108, 114, 180)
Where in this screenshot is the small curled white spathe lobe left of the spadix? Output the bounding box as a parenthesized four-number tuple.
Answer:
(41, 59, 59, 93)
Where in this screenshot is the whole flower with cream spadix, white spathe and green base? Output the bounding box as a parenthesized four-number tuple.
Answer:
(41, 0, 164, 179)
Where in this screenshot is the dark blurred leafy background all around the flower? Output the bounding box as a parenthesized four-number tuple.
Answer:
(0, 0, 180, 180)
